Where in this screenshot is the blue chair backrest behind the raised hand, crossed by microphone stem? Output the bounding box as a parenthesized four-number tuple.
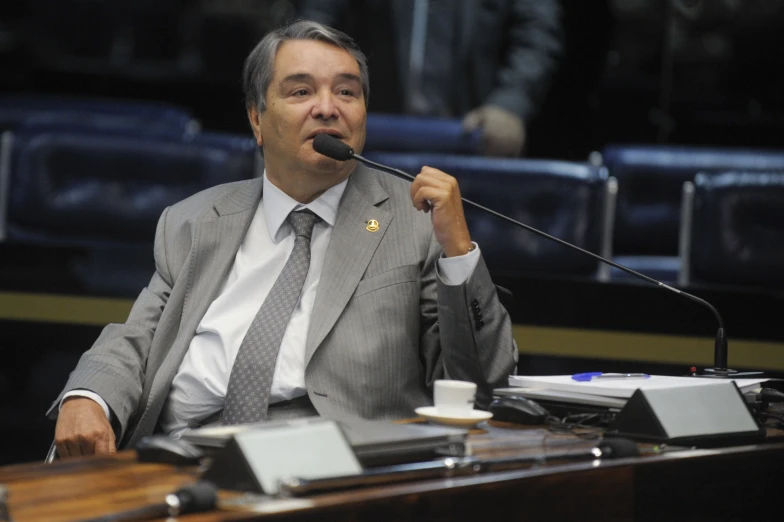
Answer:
(367, 153, 607, 276)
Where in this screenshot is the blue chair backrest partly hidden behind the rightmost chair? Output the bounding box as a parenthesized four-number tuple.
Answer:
(602, 145, 784, 255)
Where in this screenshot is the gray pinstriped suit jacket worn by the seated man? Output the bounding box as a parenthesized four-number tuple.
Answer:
(49, 165, 517, 446)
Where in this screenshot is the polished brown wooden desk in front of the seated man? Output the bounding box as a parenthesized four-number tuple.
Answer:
(0, 423, 784, 522)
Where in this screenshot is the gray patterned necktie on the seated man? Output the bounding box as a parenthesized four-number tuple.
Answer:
(222, 210, 320, 424)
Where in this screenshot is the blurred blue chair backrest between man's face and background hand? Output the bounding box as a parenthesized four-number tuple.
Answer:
(364, 113, 481, 154)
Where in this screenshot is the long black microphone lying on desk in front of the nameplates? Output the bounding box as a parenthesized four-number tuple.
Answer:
(280, 438, 640, 497)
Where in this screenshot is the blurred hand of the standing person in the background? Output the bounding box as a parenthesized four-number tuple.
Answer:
(463, 105, 525, 158)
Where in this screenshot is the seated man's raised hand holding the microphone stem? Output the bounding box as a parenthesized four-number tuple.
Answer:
(411, 167, 472, 257)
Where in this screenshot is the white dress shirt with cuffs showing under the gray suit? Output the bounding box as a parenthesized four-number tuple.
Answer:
(64, 173, 480, 437)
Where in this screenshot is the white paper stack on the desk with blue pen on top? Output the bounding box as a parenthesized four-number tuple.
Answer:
(509, 375, 769, 399)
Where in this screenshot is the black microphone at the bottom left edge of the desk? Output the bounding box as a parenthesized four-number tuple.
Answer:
(84, 480, 218, 522)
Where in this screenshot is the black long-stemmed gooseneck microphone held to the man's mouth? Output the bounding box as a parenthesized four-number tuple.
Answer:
(313, 134, 762, 378)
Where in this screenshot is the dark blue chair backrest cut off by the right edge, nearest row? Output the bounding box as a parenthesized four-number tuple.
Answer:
(690, 171, 784, 288)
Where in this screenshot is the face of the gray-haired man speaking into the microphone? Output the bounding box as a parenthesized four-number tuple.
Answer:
(248, 40, 367, 199)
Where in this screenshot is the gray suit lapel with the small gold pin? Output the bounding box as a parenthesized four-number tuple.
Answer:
(305, 165, 393, 366)
